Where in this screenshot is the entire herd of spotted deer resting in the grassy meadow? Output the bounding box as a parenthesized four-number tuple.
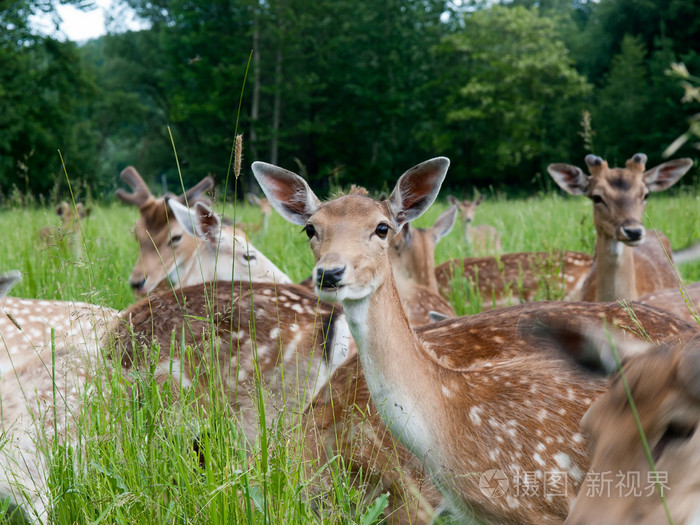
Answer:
(0, 154, 700, 525)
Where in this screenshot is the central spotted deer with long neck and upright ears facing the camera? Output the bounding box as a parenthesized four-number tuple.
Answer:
(252, 157, 694, 524)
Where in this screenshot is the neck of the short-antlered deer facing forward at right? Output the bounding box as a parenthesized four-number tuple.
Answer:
(595, 232, 638, 302)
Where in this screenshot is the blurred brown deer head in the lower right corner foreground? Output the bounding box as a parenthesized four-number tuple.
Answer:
(544, 322, 700, 525)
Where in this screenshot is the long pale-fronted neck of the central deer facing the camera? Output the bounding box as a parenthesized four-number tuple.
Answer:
(343, 258, 435, 456)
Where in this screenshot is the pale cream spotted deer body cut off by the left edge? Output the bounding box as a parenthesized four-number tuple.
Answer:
(0, 270, 116, 522)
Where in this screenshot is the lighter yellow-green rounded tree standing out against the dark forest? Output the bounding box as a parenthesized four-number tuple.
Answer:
(439, 6, 589, 189)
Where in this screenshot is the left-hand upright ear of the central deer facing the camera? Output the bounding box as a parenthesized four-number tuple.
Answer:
(253, 162, 321, 226)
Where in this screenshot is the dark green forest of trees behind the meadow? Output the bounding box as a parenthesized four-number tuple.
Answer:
(0, 0, 700, 203)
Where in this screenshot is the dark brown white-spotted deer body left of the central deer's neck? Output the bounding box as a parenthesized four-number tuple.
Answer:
(106, 281, 351, 442)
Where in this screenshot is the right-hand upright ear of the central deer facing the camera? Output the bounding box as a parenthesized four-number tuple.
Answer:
(386, 157, 450, 228)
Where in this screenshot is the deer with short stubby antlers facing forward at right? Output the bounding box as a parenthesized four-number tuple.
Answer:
(547, 153, 693, 301)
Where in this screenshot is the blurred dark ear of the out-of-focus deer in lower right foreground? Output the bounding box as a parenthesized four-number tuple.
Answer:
(519, 319, 653, 377)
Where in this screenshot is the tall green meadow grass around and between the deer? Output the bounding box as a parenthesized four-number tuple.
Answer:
(0, 177, 700, 525)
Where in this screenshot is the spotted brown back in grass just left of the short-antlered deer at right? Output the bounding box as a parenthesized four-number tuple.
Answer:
(435, 251, 593, 309)
